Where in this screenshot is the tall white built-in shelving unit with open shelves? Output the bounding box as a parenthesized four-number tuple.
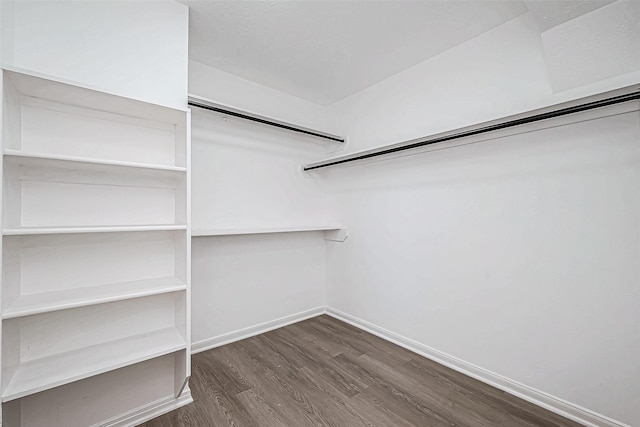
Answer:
(0, 68, 191, 427)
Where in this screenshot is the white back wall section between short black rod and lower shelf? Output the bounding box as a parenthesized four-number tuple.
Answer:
(192, 108, 335, 229)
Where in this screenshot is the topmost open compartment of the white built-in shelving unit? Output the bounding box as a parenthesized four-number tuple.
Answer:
(2, 68, 189, 171)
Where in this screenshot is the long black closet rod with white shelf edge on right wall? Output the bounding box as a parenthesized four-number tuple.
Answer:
(303, 91, 640, 171)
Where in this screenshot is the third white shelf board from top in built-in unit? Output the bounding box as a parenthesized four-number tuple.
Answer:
(2, 277, 187, 319)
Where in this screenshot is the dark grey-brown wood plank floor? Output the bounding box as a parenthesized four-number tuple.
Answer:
(142, 316, 579, 427)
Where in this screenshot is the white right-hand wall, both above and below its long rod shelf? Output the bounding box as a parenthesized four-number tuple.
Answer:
(318, 8, 640, 425)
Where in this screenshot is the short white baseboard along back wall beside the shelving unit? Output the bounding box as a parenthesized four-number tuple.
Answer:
(191, 306, 326, 354)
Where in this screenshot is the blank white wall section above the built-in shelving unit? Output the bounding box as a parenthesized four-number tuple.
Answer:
(2, 0, 189, 108)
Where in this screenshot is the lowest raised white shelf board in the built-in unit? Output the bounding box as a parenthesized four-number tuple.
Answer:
(2, 328, 187, 402)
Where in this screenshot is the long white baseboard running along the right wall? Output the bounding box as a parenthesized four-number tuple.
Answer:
(326, 307, 630, 427)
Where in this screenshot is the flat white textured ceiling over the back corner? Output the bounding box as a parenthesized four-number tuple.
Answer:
(181, 0, 524, 105)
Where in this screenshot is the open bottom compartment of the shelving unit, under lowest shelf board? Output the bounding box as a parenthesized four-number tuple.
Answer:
(2, 350, 192, 427)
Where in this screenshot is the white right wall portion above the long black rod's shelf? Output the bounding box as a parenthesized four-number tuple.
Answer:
(329, 10, 640, 156)
